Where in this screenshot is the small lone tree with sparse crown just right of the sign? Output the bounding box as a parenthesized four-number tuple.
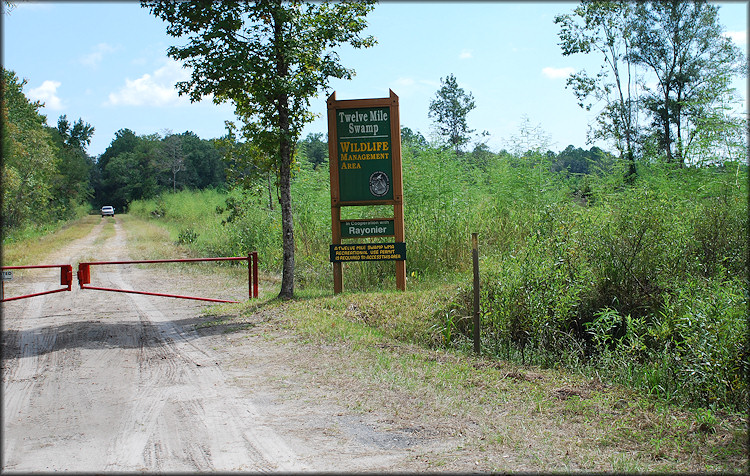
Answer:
(428, 74, 475, 153)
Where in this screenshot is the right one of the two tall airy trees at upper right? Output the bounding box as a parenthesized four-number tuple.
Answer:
(631, 0, 746, 165)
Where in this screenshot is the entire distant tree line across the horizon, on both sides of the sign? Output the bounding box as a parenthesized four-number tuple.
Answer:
(2, 54, 740, 242)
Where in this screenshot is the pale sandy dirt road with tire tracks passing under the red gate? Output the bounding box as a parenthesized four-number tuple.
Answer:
(2, 217, 455, 473)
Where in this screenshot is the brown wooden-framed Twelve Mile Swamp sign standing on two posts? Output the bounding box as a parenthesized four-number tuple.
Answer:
(327, 87, 406, 294)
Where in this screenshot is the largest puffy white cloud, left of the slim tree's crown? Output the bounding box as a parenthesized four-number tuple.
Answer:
(105, 60, 190, 107)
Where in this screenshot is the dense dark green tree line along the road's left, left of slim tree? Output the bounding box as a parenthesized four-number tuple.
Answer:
(1, 68, 226, 238)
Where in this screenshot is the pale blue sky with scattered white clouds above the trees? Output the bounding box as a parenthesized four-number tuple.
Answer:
(2, 1, 748, 157)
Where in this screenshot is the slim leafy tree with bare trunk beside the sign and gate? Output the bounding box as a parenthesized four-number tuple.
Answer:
(141, 0, 375, 298)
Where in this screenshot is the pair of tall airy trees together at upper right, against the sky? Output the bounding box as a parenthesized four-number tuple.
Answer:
(555, 1, 747, 167)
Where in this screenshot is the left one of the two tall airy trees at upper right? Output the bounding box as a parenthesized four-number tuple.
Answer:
(555, 0, 638, 176)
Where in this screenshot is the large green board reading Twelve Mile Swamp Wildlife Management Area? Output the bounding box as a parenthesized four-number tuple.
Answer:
(335, 107, 393, 202)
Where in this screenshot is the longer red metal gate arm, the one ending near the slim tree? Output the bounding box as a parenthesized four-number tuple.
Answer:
(78, 255, 258, 303)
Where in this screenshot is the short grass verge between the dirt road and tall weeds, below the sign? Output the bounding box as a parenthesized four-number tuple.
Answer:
(204, 294, 748, 473)
